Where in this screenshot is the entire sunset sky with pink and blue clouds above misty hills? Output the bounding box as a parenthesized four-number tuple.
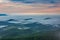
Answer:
(0, 0, 60, 15)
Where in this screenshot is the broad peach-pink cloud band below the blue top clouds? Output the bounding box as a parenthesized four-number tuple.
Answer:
(0, 3, 60, 14)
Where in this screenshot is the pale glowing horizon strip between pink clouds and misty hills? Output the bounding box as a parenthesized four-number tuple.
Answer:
(0, 13, 60, 15)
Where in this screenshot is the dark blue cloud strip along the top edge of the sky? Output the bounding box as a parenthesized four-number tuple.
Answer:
(11, 0, 60, 3)
